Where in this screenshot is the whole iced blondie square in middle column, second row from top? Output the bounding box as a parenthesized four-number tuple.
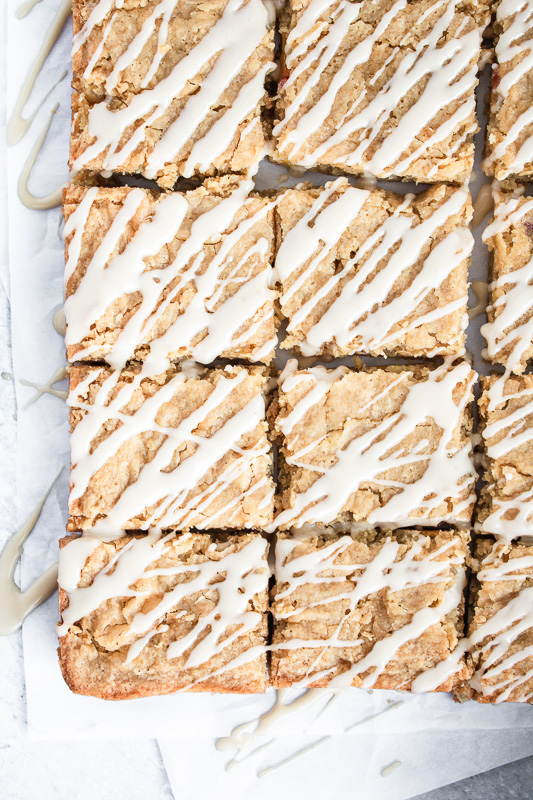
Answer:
(275, 178, 474, 357)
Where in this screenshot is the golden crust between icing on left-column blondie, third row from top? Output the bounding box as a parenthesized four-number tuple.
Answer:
(67, 365, 273, 531)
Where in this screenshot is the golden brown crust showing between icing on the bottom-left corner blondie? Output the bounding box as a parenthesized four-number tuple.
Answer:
(58, 533, 268, 700)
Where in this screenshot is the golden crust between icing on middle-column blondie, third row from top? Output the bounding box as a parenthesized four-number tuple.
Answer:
(271, 365, 474, 528)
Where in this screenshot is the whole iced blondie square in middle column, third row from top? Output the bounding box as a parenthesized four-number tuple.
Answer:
(272, 361, 476, 529)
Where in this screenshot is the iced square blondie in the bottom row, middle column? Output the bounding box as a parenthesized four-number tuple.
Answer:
(271, 526, 468, 691)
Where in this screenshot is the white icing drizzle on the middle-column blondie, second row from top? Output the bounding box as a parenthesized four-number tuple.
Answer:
(276, 179, 474, 356)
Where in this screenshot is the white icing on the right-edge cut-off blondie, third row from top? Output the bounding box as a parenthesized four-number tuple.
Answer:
(481, 372, 533, 541)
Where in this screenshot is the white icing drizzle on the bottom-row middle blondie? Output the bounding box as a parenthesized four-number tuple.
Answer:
(273, 533, 466, 688)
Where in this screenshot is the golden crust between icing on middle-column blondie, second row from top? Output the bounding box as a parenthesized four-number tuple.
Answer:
(277, 179, 472, 358)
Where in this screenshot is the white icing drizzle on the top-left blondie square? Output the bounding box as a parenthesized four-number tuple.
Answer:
(72, 0, 274, 179)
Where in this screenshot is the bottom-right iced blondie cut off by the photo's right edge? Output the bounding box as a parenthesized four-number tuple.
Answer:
(457, 538, 533, 703)
